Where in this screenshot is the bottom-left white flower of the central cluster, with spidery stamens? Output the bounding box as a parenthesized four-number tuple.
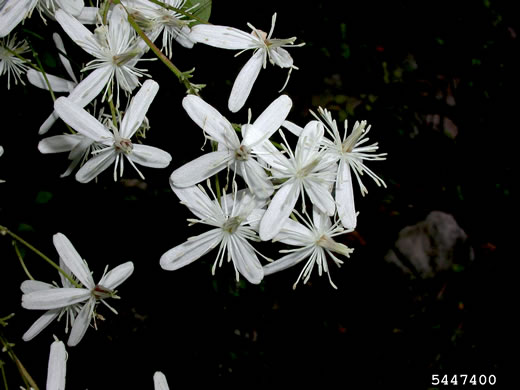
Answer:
(160, 185, 264, 284)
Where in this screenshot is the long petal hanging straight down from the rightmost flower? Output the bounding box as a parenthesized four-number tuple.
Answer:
(336, 159, 357, 229)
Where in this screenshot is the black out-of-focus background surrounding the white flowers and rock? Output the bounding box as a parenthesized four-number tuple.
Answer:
(0, 0, 520, 389)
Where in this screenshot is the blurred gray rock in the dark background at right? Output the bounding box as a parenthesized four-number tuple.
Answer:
(385, 211, 474, 278)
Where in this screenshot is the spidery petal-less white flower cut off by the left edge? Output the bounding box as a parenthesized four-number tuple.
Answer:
(0, 34, 29, 89)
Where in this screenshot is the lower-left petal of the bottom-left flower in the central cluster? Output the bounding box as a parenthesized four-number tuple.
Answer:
(159, 229, 222, 271)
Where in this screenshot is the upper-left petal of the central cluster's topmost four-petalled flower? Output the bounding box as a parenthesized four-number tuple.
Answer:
(182, 95, 240, 149)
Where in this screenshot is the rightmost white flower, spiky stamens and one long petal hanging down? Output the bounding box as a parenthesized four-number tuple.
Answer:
(318, 107, 386, 229)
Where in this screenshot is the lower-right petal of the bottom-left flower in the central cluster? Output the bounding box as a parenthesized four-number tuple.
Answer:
(228, 235, 264, 284)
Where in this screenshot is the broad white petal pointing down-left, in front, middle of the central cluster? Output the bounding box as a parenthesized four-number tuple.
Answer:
(259, 181, 300, 241)
